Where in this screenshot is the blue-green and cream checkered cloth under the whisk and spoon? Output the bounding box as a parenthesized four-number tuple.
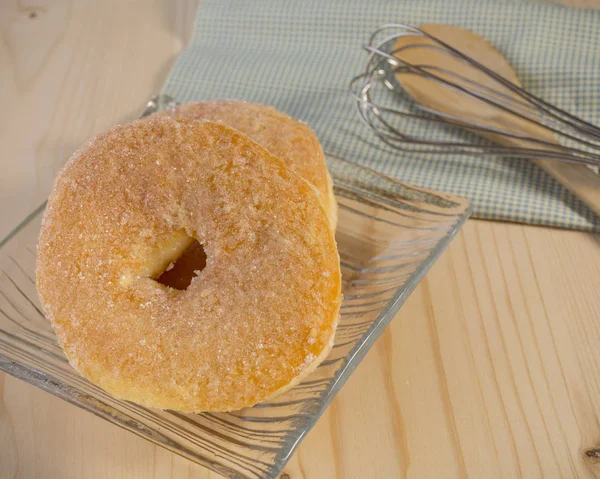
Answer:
(163, 0, 600, 231)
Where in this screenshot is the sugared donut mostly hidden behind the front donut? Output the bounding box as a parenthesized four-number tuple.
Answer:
(155, 100, 337, 229)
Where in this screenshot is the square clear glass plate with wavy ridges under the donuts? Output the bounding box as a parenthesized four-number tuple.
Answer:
(0, 95, 469, 478)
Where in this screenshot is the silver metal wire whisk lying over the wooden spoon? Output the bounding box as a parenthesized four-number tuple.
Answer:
(350, 24, 600, 170)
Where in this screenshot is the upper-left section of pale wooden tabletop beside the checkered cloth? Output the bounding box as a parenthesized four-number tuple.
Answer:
(0, 0, 197, 237)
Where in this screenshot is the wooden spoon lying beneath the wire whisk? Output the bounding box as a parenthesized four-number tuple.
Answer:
(394, 24, 600, 220)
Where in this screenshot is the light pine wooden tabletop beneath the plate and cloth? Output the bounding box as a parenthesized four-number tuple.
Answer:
(0, 0, 600, 479)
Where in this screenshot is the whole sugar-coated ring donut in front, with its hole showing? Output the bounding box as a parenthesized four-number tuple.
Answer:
(36, 116, 341, 412)
